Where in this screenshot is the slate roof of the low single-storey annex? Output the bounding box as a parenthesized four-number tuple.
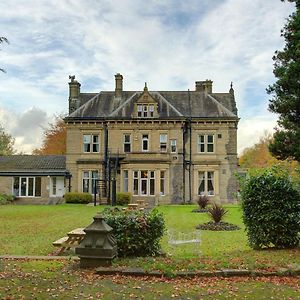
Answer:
(0, 155, 66, 172)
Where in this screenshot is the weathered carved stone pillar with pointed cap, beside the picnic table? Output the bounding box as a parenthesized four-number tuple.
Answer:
(75, 214, 117, 268)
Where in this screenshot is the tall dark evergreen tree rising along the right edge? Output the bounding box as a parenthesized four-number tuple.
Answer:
(267, 0, 300, 162)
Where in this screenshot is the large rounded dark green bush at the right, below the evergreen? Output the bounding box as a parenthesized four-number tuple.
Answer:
(241, 168, 300, 249)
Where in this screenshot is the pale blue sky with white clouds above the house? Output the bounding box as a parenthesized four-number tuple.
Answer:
(0, 0, 295, 154)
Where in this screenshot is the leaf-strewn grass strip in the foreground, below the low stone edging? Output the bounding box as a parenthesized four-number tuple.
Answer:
(0, 260, 300, 300)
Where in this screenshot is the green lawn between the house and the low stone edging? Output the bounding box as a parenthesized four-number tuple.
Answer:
(0, 204, 300, 274)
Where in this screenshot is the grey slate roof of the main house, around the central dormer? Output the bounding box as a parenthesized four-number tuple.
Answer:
(68, 91, 237, 119)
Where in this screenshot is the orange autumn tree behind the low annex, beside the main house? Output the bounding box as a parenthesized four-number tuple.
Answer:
(32, 116, 67, 155)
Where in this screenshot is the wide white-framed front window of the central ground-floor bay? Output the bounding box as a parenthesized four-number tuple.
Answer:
(133, 170, 155, 196)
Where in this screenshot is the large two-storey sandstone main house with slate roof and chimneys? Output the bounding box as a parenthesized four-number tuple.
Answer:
(65, 74, 238, 204)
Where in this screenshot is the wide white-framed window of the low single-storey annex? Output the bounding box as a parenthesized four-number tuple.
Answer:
(13, 177, 41, 197)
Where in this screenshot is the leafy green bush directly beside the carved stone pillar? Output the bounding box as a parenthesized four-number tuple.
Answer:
(103, 208, 165, 257)
